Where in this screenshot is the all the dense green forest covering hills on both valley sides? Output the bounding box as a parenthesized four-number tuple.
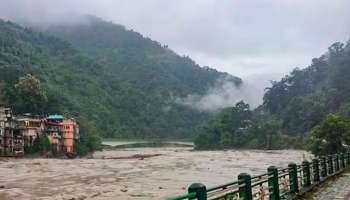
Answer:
(0, 16, 350, 152)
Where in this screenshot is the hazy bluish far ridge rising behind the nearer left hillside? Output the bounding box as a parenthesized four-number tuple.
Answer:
(47, 16, 241, 98)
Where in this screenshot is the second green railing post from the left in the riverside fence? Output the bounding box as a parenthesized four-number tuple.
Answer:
(238, 173, 253, 200)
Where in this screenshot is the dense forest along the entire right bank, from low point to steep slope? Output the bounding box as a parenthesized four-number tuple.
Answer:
(196, 41, 350, 152)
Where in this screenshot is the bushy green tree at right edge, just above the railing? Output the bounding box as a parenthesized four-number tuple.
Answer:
(308, 114, 350, 155)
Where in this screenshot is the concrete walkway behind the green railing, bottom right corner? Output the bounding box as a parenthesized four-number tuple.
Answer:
(302, 170, 350, 200)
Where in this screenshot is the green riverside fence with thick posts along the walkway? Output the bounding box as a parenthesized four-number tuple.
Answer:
(167, 152, 350, 200)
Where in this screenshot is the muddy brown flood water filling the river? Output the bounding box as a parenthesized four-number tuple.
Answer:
(0, 147, 310, 200)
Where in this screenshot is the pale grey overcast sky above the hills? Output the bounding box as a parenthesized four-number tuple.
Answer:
(0, 0, 350, 79)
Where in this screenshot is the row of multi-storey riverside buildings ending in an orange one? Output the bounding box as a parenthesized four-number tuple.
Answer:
(0, 105, 79, 156)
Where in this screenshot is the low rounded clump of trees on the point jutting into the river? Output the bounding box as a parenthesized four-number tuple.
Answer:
(195, 101, 294, 149)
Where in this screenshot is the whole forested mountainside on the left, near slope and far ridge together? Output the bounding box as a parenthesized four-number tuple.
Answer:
(0, 17, 241, 138)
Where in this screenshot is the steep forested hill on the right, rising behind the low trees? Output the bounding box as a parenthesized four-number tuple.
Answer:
(263, 42, 350, 135)
